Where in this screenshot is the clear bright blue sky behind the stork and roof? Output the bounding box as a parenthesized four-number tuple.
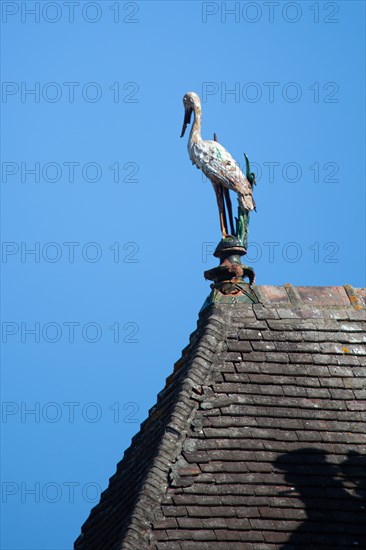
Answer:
(1, 0, 365, 550)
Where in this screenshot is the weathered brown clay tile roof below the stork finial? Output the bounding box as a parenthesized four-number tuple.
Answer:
(75, 285, 366, 550)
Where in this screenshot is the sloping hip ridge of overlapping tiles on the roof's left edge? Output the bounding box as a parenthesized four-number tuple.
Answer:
(119, 305, 231, 550)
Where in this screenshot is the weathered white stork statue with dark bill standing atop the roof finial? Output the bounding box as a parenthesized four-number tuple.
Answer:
(180, 92, 255, 238)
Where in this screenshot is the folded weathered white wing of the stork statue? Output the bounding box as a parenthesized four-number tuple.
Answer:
(196, 140, 254, 210)
